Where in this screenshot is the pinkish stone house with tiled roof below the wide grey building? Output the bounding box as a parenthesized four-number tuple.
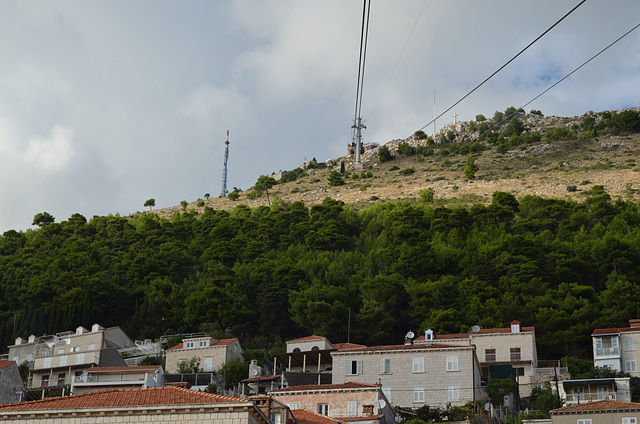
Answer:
(269, 382, 395, 424)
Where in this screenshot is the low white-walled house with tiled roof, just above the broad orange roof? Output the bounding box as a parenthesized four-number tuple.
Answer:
(71, 365, 164, 395)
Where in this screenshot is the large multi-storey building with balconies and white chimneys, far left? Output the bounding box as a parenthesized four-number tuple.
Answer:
(9, 324, 132, 389)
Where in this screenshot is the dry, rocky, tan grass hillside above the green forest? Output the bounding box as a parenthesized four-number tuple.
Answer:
(155, 108, 640, 216)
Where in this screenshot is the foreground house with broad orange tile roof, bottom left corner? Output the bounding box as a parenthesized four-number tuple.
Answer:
(0, 387, 270, 424)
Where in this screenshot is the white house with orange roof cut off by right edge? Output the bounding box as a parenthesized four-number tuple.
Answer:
(591, 319, 640, 377)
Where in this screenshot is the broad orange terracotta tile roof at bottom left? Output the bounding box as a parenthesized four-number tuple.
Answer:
(0, 387, 248, 411)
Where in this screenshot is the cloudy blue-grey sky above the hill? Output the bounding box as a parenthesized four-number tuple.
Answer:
(0, 0, 640, 234)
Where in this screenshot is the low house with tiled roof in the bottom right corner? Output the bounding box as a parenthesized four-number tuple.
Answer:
(550, 400, 640, 424)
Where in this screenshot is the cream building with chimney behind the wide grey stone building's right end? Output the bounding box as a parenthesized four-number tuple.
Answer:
(415, 321, 538, 397)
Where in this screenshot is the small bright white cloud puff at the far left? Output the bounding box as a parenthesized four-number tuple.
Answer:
(25, 125, 75, 173)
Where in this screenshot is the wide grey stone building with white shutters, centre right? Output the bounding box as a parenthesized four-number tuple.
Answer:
(331, 342, 481, 408)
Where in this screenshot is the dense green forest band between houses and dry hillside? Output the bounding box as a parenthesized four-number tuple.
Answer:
(0, 186, 640, 359)
